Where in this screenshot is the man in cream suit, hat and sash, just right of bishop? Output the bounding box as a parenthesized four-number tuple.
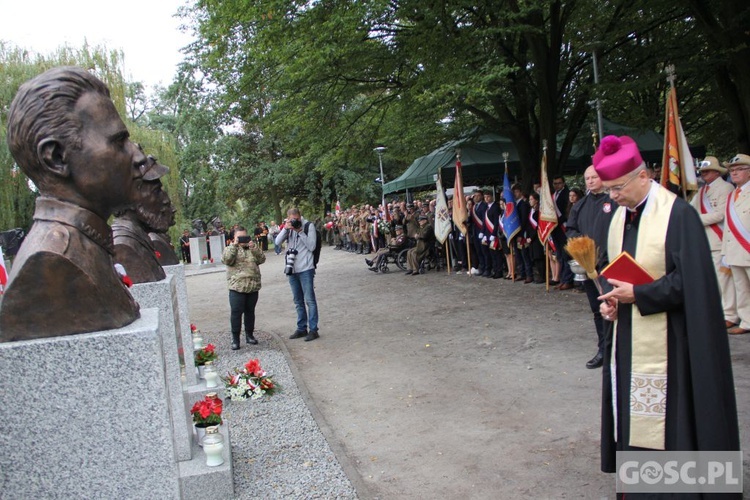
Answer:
(690, 156, 739, 328)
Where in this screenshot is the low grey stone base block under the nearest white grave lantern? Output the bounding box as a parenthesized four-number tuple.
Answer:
(179, 425, 234, 500)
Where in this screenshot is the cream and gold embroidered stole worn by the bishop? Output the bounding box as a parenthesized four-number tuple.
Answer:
(608, 183, 676, 450)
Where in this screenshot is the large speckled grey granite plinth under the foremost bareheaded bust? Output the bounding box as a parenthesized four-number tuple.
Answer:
(0, 308, 182, 499)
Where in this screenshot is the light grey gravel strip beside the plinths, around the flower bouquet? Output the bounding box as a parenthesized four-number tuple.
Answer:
(201, 325, 357, 499)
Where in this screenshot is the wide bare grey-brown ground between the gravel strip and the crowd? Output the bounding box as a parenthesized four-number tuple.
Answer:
(188, 247, 750, 499)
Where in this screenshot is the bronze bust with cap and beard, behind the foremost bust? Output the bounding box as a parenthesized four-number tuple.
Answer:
(112, 156, 176, 283)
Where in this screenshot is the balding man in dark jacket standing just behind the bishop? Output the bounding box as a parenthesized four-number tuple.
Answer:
(566, 165, 615, 368)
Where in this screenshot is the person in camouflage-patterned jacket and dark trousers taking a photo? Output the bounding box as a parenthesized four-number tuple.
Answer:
(221, 226, 266, 351)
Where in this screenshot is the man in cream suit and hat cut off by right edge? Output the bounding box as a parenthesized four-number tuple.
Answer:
(721, 154, 750, 335)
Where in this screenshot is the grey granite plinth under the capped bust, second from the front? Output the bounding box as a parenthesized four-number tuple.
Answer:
(130, 275, 193, 461)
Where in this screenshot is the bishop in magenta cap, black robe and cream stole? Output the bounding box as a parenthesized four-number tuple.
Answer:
(594, 136, 739, 498)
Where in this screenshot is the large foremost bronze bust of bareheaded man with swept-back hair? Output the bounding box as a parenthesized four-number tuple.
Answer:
(0, 67, 146, 342)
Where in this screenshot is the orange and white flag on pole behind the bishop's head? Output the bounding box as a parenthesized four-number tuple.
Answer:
(661, 87, 698, 196)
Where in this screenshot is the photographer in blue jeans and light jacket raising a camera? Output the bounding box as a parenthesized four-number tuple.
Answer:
(274, 208, 319, 342)
